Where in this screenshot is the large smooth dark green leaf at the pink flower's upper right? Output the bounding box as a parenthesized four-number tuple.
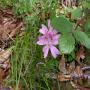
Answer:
(52, 17, 73, 33)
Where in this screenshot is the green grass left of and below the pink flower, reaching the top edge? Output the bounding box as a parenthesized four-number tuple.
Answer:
(0, 0, 89, 90)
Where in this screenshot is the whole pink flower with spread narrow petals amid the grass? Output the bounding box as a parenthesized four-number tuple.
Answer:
(37, 20, 60, 58)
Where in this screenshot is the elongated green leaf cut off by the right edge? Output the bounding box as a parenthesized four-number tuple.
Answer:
(74, 30, 90, 49)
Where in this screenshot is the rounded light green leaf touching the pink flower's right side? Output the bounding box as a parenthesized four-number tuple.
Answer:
(59, 34, 75, 54)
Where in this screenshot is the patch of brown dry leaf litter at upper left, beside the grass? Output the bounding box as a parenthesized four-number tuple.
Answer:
(0, 7, 25, 48)
